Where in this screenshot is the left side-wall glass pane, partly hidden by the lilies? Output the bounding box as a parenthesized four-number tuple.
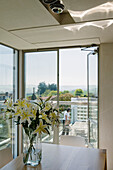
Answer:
(0, 45, 17, 157)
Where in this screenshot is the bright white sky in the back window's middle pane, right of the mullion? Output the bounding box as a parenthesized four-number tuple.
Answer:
(59, 48, 87, 86)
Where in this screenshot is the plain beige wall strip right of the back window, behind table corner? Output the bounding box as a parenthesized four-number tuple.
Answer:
(99, 43, 113, 170)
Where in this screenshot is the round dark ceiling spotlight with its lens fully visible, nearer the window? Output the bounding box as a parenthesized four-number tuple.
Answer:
(50, 0, 64, 14)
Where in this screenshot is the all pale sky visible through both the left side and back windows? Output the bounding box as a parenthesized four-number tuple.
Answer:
(0, 45, 97, 93)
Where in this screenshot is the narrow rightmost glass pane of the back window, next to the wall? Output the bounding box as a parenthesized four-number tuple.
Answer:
(89, 48, 98, 148)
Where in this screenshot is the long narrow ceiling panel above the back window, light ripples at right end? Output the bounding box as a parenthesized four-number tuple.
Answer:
(12, 20, 113, 44)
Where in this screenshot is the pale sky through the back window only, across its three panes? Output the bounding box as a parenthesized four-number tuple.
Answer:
(26, 48, 96, 86)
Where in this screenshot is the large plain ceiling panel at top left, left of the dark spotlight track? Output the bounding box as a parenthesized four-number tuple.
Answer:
(0, 0, 58, 30)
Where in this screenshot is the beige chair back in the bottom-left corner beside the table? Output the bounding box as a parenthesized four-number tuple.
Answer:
(0, 148, 13, 168)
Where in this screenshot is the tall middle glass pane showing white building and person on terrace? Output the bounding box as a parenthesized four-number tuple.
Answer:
(59, 48, 88, 146)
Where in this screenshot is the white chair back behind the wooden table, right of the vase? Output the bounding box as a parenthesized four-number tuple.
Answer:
(60, 135, 85, 147)
